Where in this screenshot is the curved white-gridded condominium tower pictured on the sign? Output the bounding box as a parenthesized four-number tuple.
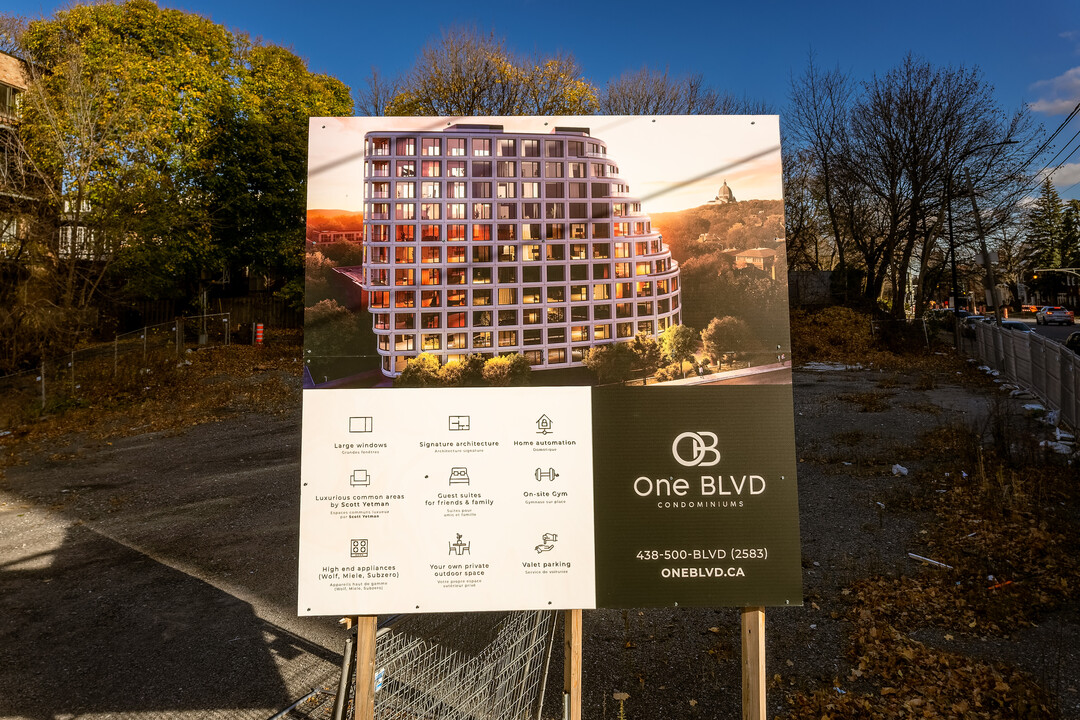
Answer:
(361, 124, 679, 377)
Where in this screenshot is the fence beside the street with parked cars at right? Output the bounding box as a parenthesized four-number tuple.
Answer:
(972, 323, 1080, 427)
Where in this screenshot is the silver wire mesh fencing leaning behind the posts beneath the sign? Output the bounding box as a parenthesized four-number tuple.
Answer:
(279, 610, 558, 720)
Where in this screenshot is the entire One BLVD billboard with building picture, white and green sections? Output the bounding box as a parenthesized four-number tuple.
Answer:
(298, 117, 801, 615)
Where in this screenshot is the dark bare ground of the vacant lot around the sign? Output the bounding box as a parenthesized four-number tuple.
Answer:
(0, 359, 1080, 720)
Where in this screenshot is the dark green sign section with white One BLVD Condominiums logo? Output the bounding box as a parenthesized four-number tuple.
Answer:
(593, 385, 802, 608)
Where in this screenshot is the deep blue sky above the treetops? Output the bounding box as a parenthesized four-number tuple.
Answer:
(12, 0, 1080, 198)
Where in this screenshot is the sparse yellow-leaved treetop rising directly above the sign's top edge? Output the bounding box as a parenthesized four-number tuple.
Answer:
(357, 27, 597, 116)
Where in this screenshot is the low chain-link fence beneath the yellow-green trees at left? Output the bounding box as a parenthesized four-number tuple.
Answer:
(0, 313, 230, 427)
